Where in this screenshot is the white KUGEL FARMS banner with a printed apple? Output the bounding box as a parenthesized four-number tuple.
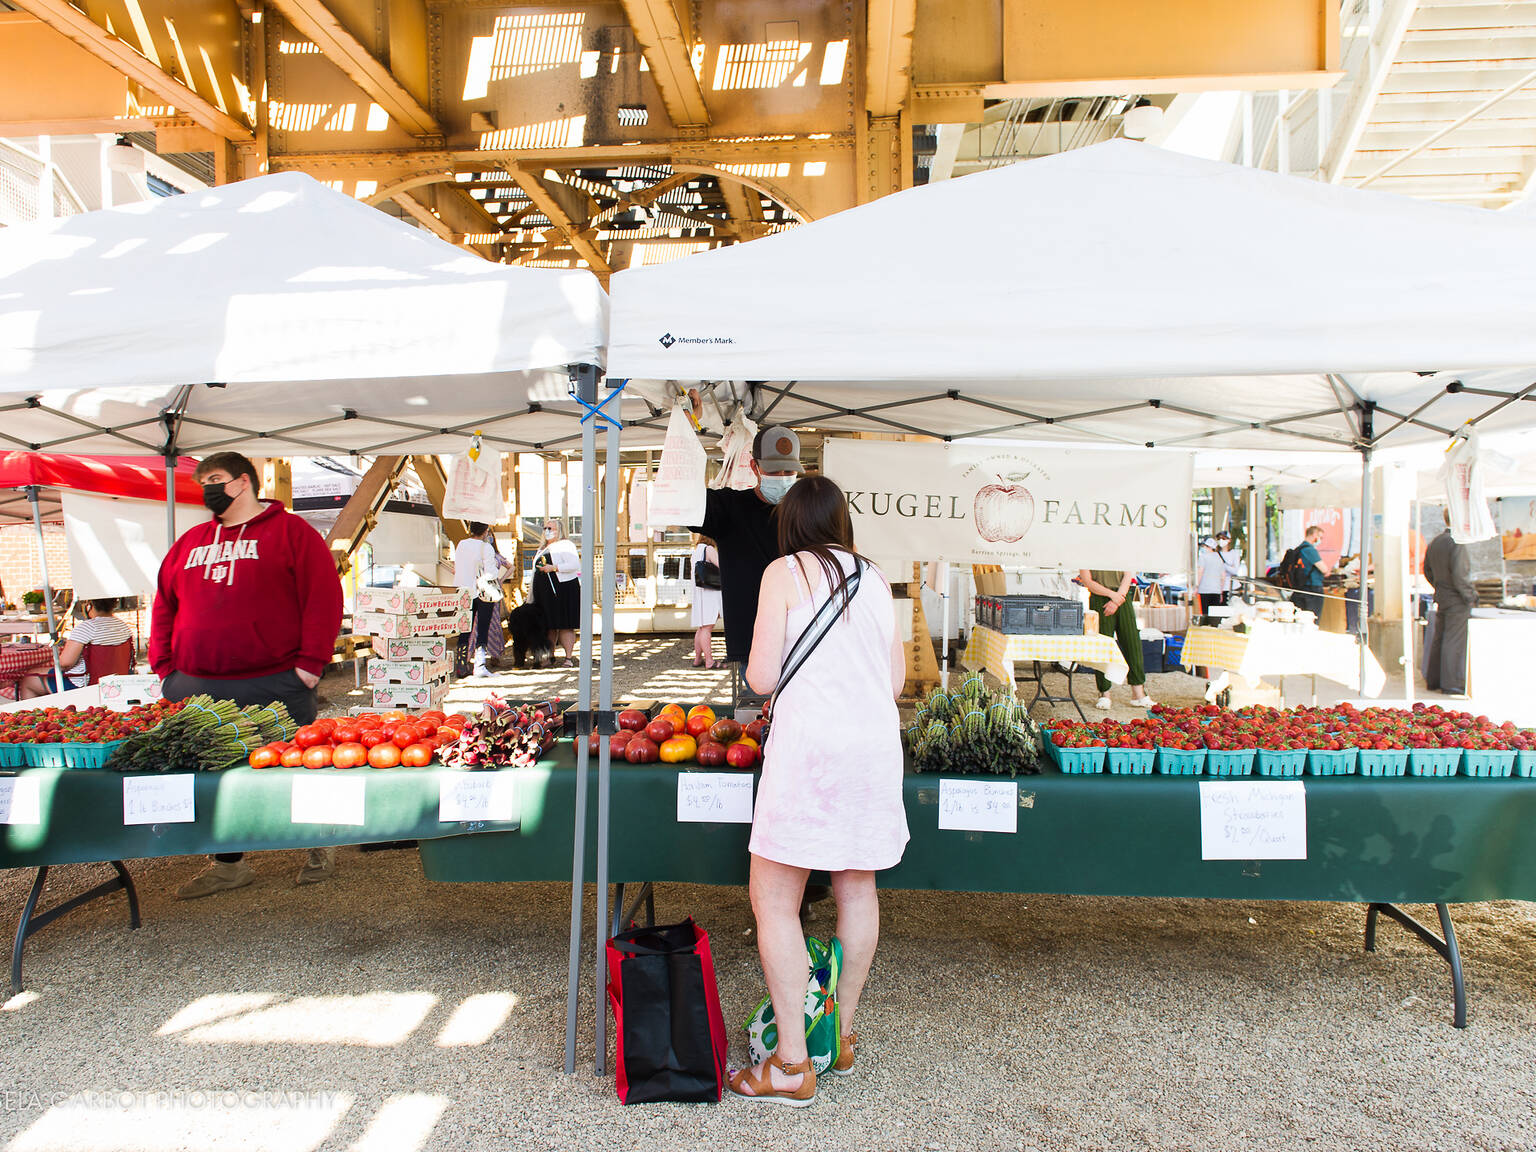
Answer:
(826, 439, 1190, 571)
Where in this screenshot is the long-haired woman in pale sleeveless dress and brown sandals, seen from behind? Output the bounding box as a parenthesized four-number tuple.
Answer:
(730, 476, 908, 1107)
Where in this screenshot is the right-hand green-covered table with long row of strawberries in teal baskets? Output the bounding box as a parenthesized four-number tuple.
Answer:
(421, 700, 1536, 1025)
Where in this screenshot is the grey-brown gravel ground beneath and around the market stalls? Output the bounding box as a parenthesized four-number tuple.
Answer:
(0, 637, 1536, 1152)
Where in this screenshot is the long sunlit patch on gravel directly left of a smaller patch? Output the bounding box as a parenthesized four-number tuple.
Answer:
(160, 992, 438, 1048)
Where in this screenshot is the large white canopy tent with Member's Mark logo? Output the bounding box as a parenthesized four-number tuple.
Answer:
(608, 140, 1536, 452)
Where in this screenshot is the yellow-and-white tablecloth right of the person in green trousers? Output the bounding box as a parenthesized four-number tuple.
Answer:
(1178, 621, 1387, 696)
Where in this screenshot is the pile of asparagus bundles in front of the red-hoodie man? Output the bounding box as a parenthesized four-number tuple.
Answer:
(108, 696, 298, 773)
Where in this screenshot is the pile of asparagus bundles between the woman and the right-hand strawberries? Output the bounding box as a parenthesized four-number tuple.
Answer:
(905, 676, 1040, 776)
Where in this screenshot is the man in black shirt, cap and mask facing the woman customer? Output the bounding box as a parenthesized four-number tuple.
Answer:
(693, 425, 802, 667)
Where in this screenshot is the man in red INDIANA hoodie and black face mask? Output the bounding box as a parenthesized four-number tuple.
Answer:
(149, 452, 341, 900)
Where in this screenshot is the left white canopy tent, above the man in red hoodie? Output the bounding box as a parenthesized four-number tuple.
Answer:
(0, 174, 607, 456)
